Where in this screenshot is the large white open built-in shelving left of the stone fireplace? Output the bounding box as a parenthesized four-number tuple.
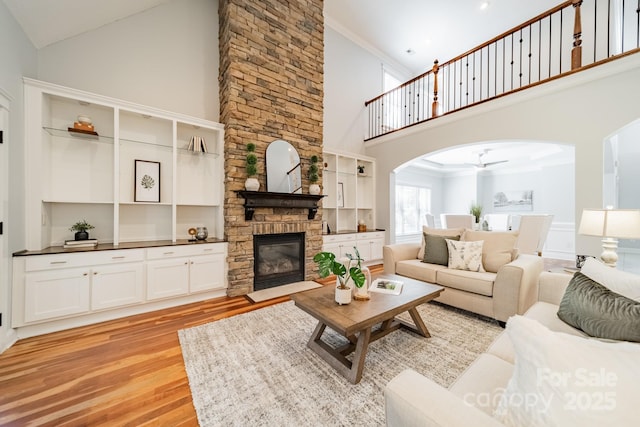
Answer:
(25, 79, 224, 250)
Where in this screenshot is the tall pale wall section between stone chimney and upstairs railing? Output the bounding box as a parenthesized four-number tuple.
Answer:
(323, 25, 382, 154)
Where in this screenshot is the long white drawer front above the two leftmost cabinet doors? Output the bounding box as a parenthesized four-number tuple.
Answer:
(25, 249, 144, 271)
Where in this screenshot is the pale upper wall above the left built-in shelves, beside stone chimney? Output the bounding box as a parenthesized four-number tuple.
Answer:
(38, 0, 220, 121)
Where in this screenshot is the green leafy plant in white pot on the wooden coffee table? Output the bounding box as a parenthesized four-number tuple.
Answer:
(313, 247, 369, 305)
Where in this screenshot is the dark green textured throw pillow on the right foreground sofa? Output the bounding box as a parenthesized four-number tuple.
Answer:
(558, 272, 640, 342)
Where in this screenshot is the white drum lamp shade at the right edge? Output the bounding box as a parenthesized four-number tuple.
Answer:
(578, 209, 640, 239)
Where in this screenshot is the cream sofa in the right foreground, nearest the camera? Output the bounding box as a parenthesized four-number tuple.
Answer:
(384, 272, 640, 427)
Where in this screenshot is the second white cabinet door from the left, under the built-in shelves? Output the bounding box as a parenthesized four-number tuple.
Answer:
(91, 263, 144, 310)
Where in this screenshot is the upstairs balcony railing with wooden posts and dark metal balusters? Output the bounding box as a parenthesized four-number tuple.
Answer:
(365, 0, 640, 140)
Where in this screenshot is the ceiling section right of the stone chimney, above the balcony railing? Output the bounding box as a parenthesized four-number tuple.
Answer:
(324, 0, 562, 76)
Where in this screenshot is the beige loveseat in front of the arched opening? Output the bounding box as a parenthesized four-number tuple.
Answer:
(383, 227, 543, 322)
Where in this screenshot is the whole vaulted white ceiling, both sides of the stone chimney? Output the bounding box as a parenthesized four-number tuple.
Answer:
(3, 0, 561, 75)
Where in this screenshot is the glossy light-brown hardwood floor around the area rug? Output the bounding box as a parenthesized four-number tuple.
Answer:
(0, 266, 358, 427)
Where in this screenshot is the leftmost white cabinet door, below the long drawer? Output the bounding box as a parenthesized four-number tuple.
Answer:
(24, 268, 90, 322)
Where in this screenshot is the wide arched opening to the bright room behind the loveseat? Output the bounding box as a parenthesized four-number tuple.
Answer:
(391, 141, 575, 260)
